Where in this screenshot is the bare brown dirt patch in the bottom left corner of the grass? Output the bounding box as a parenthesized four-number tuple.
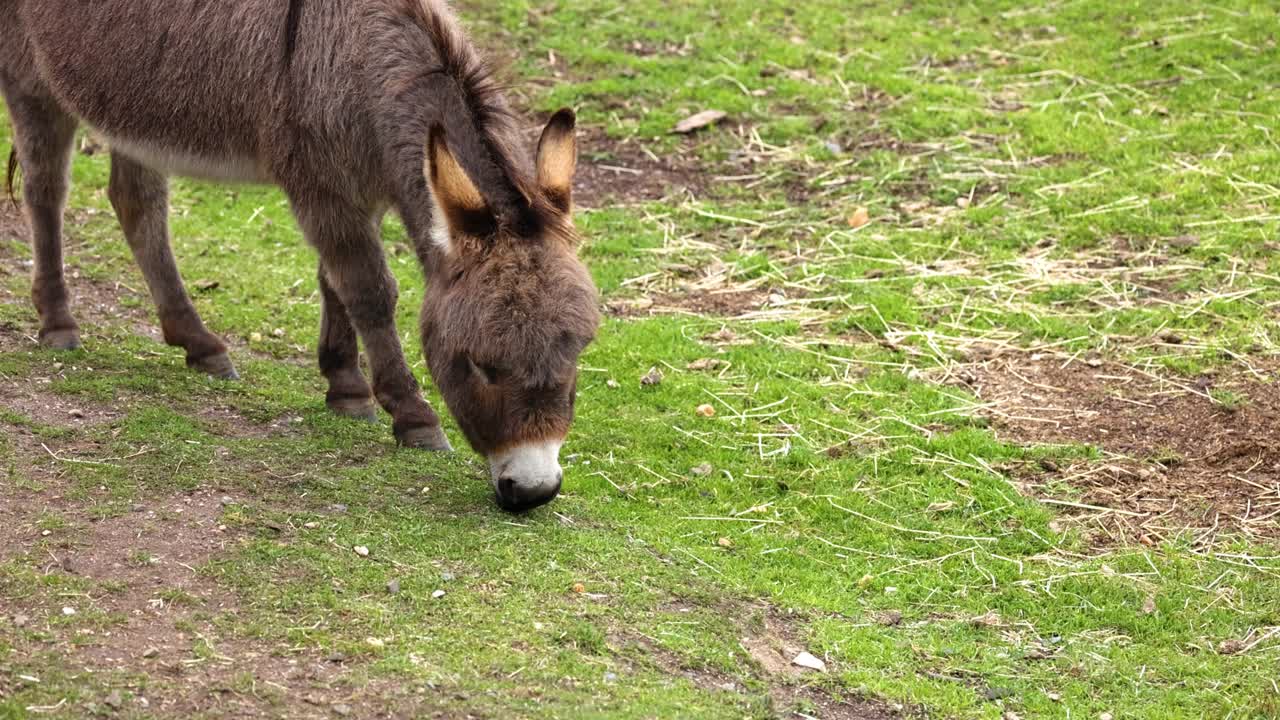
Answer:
(0, 475, 428, 719)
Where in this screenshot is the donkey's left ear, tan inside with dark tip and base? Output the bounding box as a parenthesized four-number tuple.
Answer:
(422, 126, 494, 250)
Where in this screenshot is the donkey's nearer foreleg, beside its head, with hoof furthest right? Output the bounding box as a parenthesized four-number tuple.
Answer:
(294, 197, 449, 450)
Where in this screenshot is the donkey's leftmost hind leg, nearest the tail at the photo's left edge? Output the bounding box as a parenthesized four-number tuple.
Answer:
(6, 88, 81, 350)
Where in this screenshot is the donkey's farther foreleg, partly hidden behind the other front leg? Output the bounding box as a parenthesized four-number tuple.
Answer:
(319, 266, 378, 421)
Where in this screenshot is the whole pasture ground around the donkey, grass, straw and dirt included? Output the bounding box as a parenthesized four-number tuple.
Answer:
(0, 0, 1280, 719)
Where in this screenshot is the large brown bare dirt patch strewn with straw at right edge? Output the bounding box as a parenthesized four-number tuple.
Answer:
(959, 355, 1280, 543)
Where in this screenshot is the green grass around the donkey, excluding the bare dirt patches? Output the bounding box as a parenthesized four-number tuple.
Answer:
(0, 0, 1280, 719)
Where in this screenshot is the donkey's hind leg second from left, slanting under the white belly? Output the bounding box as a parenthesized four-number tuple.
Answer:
(108, 152, 238, 379)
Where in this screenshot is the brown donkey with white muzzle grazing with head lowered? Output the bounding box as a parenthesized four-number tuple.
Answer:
(0, 0, 599, 511)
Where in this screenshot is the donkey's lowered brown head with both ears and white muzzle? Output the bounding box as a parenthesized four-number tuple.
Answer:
(421, 110, 599, 510)
